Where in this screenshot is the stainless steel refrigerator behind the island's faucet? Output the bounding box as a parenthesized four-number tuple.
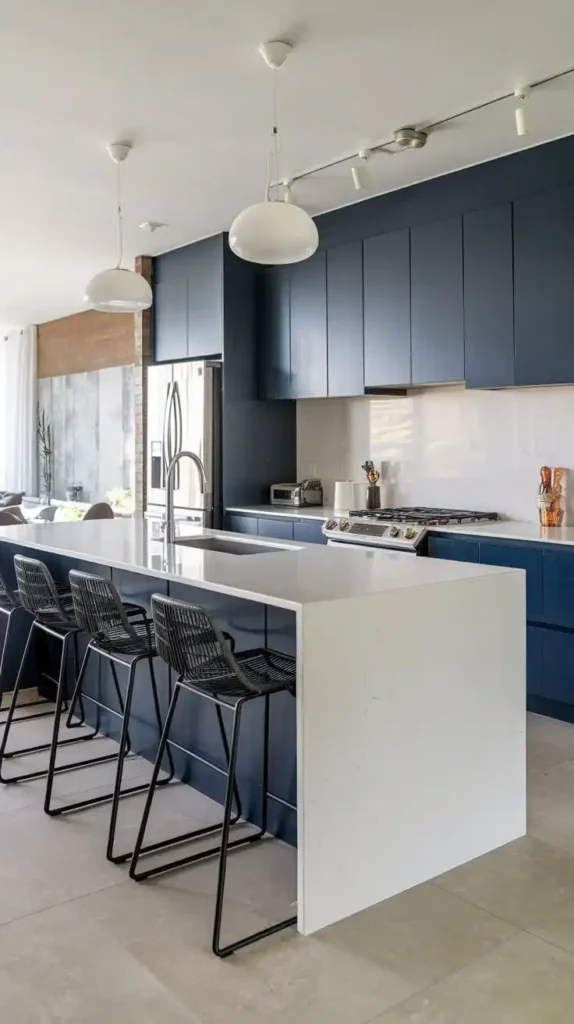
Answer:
(146, 361, 222, 528)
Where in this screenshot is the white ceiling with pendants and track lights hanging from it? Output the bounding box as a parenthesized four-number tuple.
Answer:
(0, 0, 574, 324)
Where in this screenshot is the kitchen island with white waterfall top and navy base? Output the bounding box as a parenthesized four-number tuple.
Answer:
(0, 519, 526, 935)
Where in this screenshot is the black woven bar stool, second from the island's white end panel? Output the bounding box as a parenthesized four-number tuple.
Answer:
(63, 569, 174, 864)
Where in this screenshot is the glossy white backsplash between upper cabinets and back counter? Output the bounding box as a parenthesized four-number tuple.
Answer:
(297, 386, 574, 524)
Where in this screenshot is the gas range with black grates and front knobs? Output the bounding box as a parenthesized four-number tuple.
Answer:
(322, 507, 498, 554)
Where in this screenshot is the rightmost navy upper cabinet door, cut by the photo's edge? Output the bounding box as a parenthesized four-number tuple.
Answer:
(514, 187, 574, 384)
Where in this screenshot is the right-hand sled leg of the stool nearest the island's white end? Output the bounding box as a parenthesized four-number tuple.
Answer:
(212, 694, 297, 959)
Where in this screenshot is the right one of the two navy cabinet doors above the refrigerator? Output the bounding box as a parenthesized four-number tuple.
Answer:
(187, 234, 224, 359)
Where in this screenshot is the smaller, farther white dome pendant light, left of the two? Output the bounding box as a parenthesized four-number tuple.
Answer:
(84, 142, 153, 313)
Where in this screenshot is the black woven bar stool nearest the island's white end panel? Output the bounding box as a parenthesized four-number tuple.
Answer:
(130, 594, 297, 956)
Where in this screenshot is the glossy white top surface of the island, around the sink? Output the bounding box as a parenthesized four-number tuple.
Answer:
(0, 519, 516, 610)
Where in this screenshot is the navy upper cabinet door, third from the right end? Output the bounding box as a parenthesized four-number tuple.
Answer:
(410, 217, 465, 384)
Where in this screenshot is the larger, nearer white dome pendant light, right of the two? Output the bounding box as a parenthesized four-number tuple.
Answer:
(229, 40, 319, 265)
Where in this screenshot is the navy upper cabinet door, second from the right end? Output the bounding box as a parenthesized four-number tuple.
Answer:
(463, 203, 515, 388)
